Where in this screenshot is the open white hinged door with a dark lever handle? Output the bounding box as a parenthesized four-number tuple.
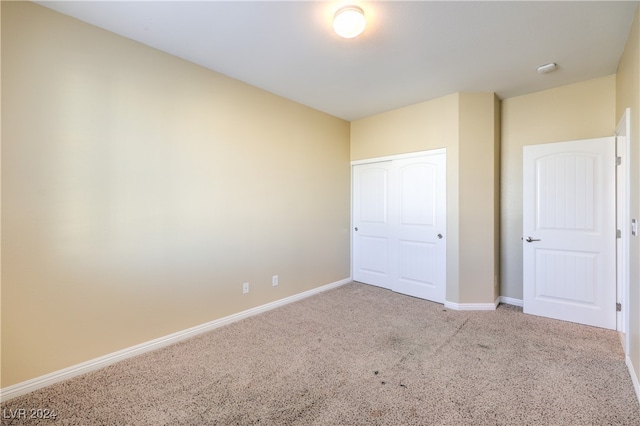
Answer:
(523, 137, 616, 329)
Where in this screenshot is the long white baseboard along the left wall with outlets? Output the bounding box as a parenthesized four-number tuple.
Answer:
(0, 278, 352, 401)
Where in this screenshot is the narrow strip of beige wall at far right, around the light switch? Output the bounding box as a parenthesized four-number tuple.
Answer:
(615, 5, 640, 397)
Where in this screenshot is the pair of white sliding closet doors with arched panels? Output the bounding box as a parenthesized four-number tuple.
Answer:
(353, 151, 446, 303)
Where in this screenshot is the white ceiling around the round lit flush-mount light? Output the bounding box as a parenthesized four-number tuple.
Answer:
(37, 0, 638, 120)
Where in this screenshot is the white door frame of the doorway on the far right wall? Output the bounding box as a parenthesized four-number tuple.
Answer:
(615, 108, 631, 354)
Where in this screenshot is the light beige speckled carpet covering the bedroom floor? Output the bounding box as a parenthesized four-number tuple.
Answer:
(2, 283, 640, 426)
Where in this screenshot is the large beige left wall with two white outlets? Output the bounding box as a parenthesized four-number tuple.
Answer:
(2, 2, 350, 387)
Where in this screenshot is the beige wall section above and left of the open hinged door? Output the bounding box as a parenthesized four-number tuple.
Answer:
(501, 75, 615, 299)
